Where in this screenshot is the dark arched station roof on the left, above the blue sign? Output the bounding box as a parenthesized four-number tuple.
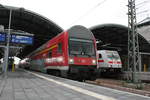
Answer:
(0, 5, 63, 57)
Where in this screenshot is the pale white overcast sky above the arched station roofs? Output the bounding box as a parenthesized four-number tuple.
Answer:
(0, 0, 150, 29)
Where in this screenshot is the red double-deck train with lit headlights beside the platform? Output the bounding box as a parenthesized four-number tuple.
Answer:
(28, 25, 97, 80)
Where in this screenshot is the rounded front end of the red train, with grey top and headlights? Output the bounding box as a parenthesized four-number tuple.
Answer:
(68, 26, 97, 78)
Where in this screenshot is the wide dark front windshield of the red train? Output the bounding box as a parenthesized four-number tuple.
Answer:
(69, 38, 95, 57)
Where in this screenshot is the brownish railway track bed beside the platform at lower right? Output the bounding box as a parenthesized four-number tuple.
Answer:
(86, 78, 150, 97)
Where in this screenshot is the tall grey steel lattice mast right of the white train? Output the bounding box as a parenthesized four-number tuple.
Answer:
(128, 0, 140, 82)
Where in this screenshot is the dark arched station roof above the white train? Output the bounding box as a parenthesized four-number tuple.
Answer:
(90, 24, 150, 54)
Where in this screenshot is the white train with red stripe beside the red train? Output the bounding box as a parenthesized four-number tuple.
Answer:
(97, 50, 122, 75)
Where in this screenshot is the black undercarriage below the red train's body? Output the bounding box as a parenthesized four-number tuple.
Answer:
(47, 66, 97, 81)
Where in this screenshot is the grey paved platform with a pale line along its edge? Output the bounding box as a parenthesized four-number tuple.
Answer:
(0, 69, 150, 100)
